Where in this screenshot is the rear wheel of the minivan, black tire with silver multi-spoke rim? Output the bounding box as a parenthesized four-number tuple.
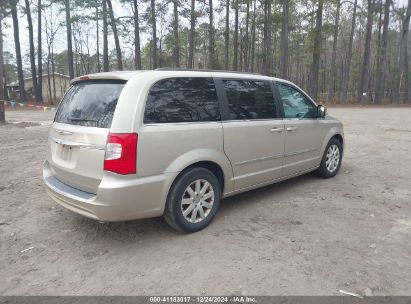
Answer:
(164, 167, 221, 233)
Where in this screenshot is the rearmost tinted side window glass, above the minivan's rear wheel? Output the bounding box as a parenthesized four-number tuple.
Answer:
(144, 77, 220, 123)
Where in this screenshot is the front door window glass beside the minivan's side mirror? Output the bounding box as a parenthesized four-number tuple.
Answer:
(276, 82, 316, 118)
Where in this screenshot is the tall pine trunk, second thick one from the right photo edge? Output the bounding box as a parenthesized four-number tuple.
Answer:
(375, 0, 391, 104)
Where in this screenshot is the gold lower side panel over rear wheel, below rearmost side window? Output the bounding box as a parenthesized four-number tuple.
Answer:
(137, 122, 233, 191)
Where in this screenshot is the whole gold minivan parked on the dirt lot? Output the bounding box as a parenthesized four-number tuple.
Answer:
(43, 69, 344, 232)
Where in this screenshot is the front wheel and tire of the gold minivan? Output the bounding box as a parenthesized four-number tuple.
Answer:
(318, 138, 343, 178)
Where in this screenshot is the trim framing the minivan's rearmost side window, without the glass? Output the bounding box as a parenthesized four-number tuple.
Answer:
(142, 75, 223, 126)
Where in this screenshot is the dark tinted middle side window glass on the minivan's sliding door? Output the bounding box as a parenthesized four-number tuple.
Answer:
(223, 80, 277, 119)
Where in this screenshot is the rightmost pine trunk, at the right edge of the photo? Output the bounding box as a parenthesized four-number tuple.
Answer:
(394, 0, 411, 103)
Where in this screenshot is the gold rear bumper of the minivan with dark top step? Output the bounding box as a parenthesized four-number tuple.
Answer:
(43, 161, 172, 222)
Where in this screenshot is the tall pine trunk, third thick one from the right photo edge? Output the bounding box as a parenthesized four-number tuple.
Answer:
(358, 0, 375, 103)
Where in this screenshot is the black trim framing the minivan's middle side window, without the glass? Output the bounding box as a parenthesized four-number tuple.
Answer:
(214, 77, 283, 122)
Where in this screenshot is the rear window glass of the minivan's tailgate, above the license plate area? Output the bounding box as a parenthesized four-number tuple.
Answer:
(54, 80, 125, 128)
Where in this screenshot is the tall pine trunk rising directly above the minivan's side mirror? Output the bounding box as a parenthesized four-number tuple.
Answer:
(310, 0, 324, 100)
